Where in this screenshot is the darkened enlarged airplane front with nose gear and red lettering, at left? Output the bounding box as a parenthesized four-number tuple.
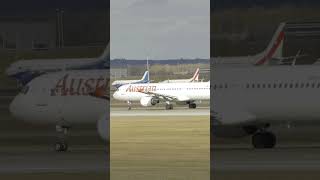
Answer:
(9, 69, 109, 152)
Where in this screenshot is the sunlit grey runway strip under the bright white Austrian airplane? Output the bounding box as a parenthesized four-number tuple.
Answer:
(110, 107, 210, 117)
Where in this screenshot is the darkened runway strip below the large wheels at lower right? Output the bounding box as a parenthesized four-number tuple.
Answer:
(211, 144, 320, 171)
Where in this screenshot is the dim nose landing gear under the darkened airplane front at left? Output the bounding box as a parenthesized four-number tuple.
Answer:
(55, 125, 70, 152)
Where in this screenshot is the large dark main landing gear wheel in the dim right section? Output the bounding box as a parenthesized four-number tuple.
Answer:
(252, 132, 276, 149)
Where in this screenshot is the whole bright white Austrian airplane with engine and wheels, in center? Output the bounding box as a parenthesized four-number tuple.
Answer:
(113, 82, 210, 110)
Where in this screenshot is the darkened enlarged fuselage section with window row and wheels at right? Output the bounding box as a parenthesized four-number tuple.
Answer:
(211, 65, 320, 148)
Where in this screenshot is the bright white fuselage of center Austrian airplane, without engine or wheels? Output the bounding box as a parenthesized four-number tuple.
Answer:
(113, 82, 210, 102)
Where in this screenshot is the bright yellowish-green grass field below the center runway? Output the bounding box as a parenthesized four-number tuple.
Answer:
(110, 116, 210, 180)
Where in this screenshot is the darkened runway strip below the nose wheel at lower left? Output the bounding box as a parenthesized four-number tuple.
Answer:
(0, 146, 109, 173)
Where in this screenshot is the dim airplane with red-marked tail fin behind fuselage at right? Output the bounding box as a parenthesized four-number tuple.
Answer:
(212, 22, 286, 66)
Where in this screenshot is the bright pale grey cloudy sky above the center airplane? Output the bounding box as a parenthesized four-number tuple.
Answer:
(110, 0, 210, 59)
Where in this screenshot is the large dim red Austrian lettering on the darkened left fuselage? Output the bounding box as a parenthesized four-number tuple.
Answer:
(51, 74, 109, 96)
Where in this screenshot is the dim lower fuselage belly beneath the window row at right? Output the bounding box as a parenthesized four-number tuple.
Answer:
(213, 89, 320, 123)
